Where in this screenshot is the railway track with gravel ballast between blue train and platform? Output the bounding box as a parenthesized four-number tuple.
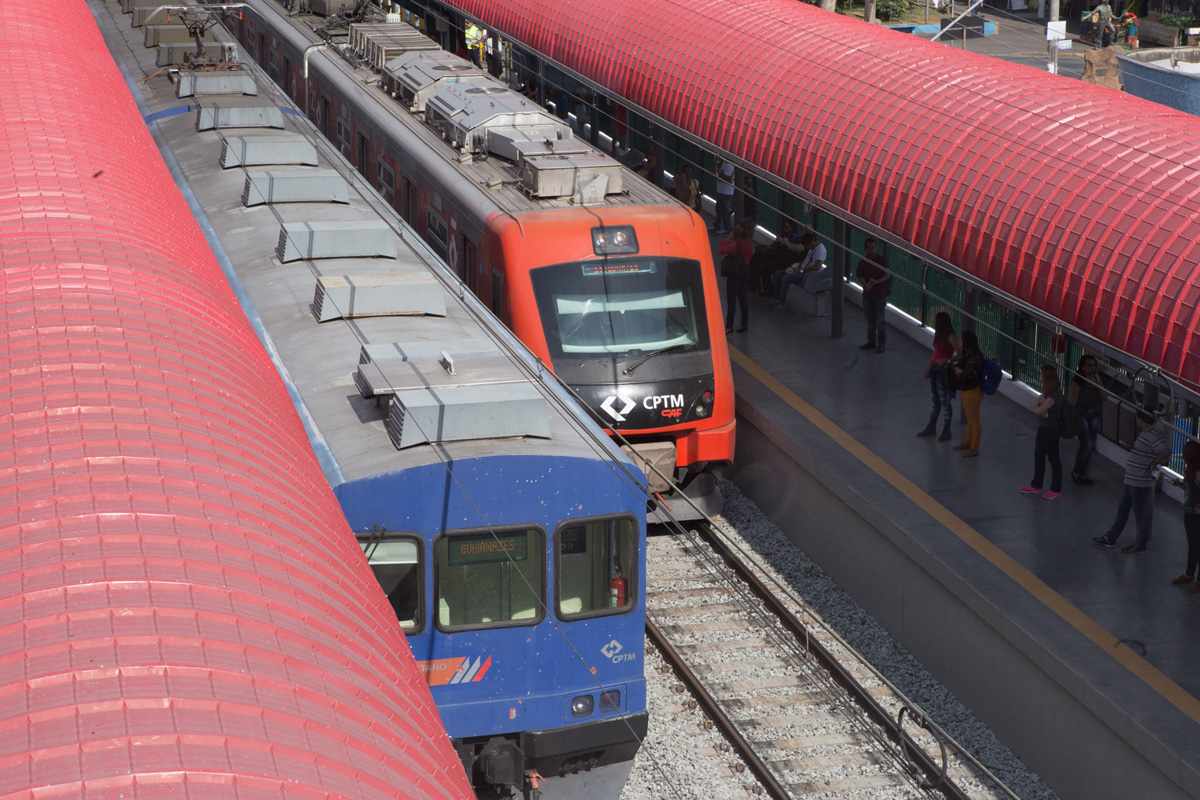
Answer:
(647, 525, 1006, 800)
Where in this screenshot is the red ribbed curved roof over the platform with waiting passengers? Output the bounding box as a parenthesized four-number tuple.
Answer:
(449, 0, 1200, 384)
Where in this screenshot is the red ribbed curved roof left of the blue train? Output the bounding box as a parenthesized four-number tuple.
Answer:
(0, 0, 470, 800)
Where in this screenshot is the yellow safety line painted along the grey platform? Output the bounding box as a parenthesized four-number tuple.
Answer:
(730, 345, 1200, 721)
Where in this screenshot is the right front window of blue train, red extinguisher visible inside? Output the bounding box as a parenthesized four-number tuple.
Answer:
(554, 517, 637, 619)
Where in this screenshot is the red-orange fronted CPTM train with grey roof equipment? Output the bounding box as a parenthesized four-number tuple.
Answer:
(233, 0, 734, 518)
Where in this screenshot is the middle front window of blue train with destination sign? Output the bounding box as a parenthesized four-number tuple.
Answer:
(433, 528, 546, 631)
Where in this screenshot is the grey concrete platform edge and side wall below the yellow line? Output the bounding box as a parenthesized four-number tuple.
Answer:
(734, 381, 1200, 799)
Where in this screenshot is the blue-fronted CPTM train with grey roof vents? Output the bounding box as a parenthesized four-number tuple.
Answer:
(92, 0, 647, 798)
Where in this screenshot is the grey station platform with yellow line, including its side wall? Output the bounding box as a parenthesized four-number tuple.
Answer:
(730, 289, 1200, 799)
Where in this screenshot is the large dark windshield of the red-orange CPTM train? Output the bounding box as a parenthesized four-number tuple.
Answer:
(533, 258, 708, 357)
